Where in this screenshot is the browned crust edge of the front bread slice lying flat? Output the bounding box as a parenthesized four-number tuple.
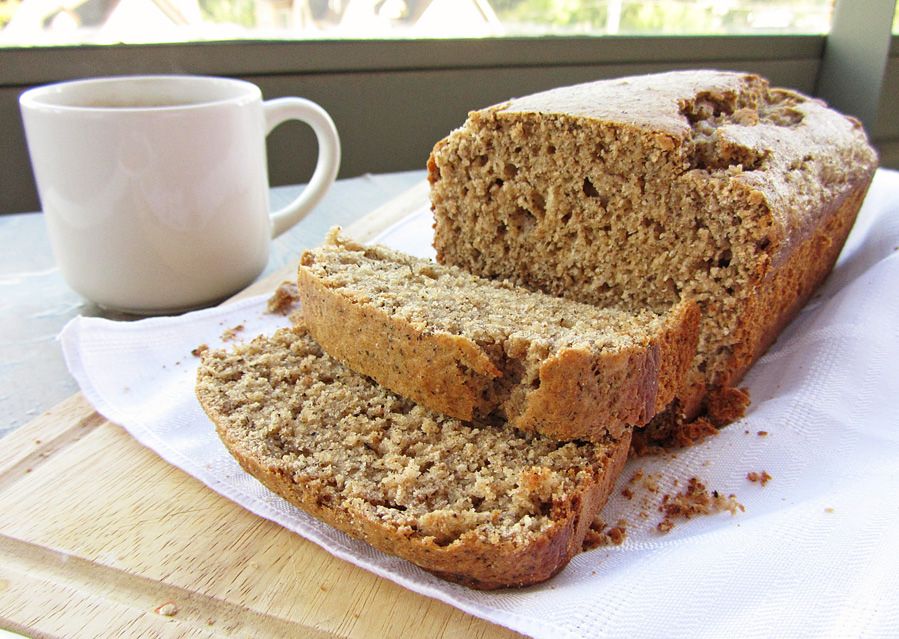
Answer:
(210, 404, 630, 590)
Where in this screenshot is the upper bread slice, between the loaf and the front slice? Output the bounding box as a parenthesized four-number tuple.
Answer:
(298, 229, 699, 441)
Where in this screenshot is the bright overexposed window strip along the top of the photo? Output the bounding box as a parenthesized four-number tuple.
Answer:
(0, 0, 832, 46)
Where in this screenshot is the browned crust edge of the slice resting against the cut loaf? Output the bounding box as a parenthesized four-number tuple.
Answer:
(298, 253, 699, 441)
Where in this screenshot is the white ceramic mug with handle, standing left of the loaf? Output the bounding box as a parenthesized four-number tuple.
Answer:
(19, 76, 340, 314)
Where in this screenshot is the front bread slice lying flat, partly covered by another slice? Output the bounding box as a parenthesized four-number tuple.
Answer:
(196, 326, 630, 589)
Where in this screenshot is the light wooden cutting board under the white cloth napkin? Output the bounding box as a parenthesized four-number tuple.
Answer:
(0, 184, 519, 638)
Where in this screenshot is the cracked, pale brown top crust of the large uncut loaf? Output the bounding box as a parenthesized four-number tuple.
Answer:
(463, 70, 877, 258)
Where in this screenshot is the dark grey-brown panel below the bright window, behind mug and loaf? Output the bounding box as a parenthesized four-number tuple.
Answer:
(0, 15, 899, 213)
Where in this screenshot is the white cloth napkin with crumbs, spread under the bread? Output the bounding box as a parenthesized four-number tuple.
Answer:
(61, 171, 899, 639)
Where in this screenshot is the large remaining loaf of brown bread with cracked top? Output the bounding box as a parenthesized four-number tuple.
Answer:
(428, 71, 877, 440)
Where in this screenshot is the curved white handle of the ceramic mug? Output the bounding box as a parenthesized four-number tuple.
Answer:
(262, 98, 340, 238)
